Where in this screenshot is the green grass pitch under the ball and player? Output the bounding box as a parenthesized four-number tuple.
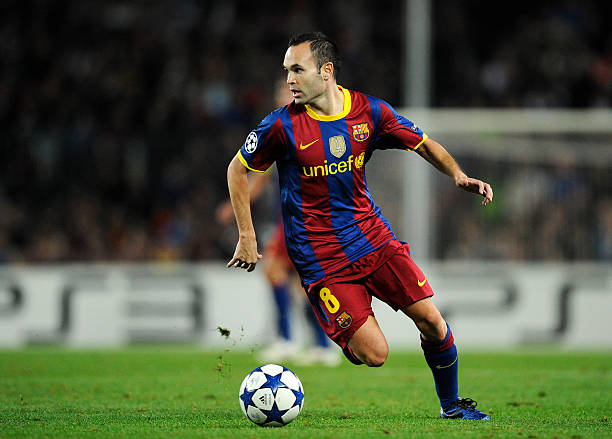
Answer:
(0, 347, 612, 439)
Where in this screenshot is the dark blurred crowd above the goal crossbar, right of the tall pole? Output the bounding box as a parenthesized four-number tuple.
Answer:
(433, 0, 612, 107)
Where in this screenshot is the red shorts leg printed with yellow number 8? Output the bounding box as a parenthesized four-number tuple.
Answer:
(308, 283, 374, 348)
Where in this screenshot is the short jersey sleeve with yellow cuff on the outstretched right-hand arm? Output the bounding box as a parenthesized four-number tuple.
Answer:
(376, 100, 428, 151)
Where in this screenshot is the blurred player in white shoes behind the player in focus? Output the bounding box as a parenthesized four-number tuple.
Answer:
(216, 78, 341, 366)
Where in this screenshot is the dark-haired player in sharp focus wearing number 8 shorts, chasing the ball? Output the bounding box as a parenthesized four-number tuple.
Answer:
(227, 32, 493, 420)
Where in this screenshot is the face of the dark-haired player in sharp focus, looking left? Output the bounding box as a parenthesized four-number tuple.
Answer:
(283, 42, 325, 104)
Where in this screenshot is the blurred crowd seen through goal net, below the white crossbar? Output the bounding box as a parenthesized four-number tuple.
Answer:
(434, 144, 612, 262)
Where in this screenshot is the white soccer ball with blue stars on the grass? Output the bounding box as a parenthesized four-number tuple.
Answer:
(238, 364, 304, 427)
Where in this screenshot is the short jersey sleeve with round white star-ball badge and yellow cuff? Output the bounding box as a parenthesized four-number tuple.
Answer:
(238, 107, 287, 172)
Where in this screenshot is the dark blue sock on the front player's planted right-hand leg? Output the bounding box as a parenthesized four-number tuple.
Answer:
(421, 324, 459, 410)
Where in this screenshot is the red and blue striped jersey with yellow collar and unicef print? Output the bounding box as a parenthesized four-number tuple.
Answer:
(238, 87, 427, 285)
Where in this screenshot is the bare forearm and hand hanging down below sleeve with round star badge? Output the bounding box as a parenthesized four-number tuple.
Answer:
(227, 154, 261, 271)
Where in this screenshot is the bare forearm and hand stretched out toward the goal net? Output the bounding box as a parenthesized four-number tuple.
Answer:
(415, 138, 493, 206)
